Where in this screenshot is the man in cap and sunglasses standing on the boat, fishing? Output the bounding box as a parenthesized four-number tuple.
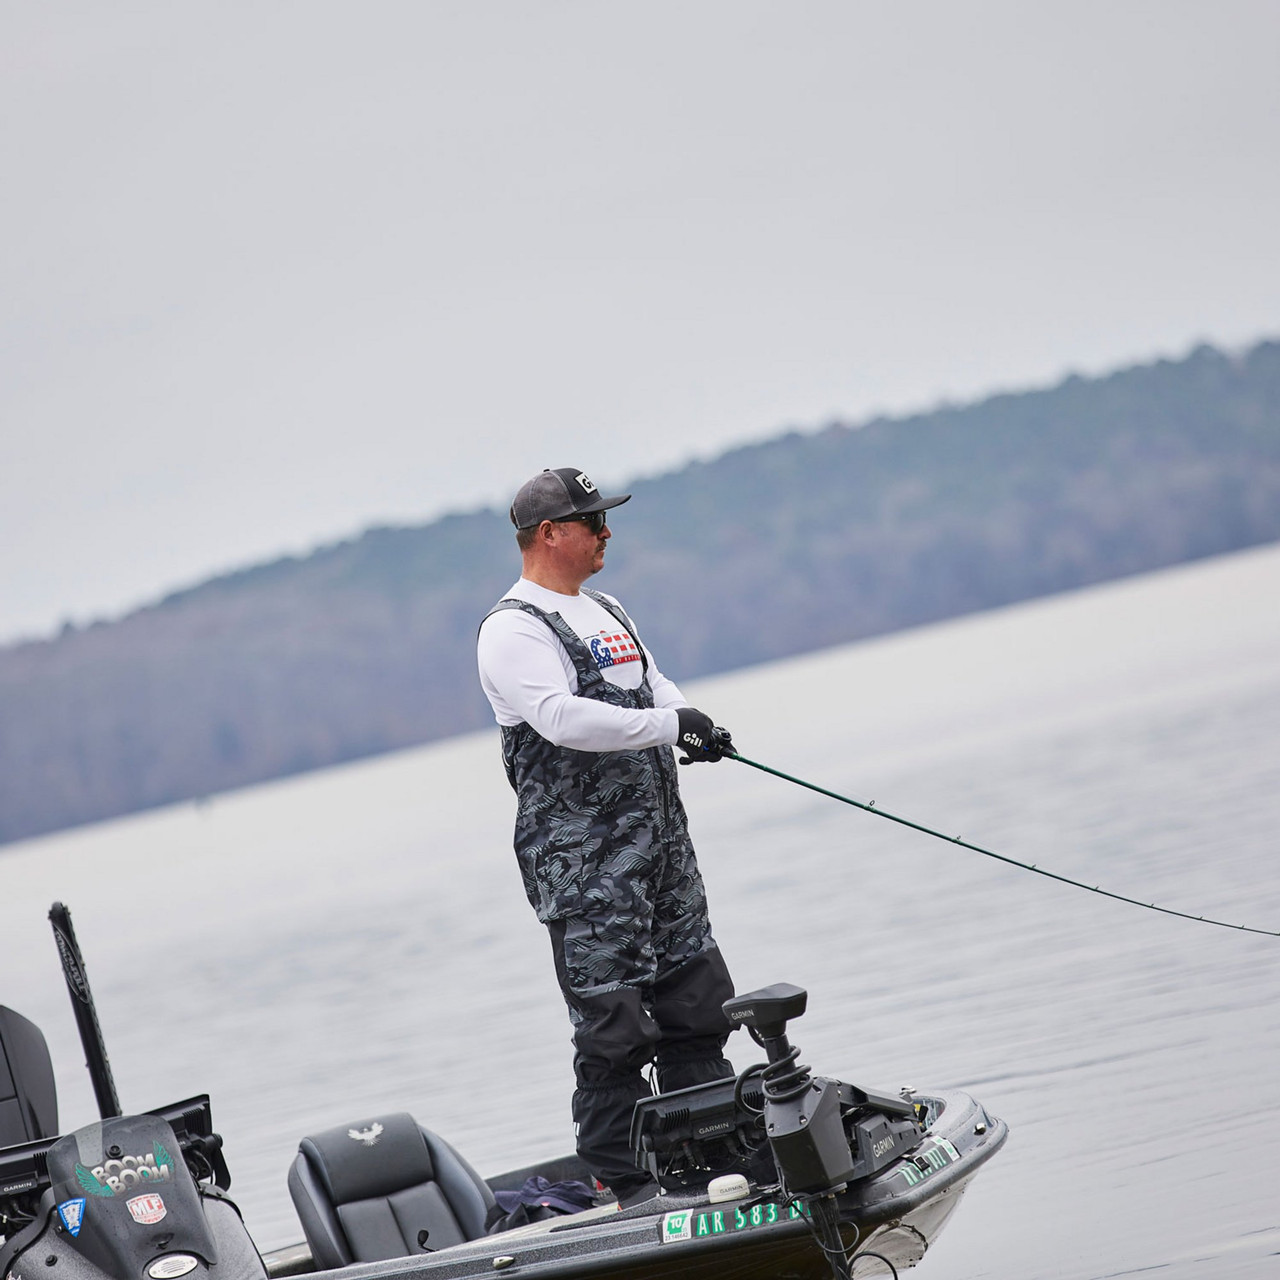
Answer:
(477, 467, 733, 1206)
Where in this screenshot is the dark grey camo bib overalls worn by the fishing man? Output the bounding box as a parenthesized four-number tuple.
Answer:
(483, 590, 733, 1192)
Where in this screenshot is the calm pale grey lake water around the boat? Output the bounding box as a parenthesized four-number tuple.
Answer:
(0, 547, 1280, 1280)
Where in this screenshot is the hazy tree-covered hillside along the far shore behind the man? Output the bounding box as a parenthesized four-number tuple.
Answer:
(0, 343, 1280, 841)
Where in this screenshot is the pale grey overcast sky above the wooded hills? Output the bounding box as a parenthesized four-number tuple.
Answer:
(0, 0, 1280, 641)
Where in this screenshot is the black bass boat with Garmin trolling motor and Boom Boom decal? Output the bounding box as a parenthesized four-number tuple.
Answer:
(0, 902, 1007, 1280)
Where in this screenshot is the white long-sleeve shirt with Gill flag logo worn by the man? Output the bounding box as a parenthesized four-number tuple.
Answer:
(476, 579, 687, 751)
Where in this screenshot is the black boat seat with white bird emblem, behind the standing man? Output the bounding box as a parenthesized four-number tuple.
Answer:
(289, 1111, 494, 1270)
